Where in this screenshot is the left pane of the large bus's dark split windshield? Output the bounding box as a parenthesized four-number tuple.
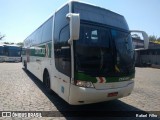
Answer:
(74, 24, 114, 76)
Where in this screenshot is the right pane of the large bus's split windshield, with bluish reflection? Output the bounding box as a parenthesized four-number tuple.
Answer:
(111, 29, 135, 75)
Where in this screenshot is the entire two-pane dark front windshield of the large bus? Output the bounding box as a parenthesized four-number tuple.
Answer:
(74, 24, 134, 76)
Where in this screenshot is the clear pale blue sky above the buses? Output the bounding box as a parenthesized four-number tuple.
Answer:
(0, 0, 160, 43)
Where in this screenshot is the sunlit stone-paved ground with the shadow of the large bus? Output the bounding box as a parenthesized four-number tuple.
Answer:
(0, 63, 160, 120)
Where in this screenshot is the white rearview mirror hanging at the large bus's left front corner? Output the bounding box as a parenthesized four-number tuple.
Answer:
(66, 13, 80, 42)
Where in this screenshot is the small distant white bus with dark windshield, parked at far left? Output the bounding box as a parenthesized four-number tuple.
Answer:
(4, 45, 22, 62)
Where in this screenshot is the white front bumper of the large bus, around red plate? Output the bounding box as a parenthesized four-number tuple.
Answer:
(68, 81, 134, 105)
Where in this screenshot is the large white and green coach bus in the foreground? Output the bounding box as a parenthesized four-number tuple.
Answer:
(22, 1, 147, 105)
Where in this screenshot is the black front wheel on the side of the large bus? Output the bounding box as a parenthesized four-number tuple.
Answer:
(43, 70, 50, 92)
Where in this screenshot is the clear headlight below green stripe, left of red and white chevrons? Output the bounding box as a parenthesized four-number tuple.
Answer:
(76, 80, 94, 88)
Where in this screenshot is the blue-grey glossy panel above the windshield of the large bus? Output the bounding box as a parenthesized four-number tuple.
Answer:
(72, 1, 129, 31)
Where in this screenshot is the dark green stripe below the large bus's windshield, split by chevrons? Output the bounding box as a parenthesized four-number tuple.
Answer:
(75, 72, 135, 83)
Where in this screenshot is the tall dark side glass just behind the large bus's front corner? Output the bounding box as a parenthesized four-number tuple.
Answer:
(54, 5, 71, 76)
